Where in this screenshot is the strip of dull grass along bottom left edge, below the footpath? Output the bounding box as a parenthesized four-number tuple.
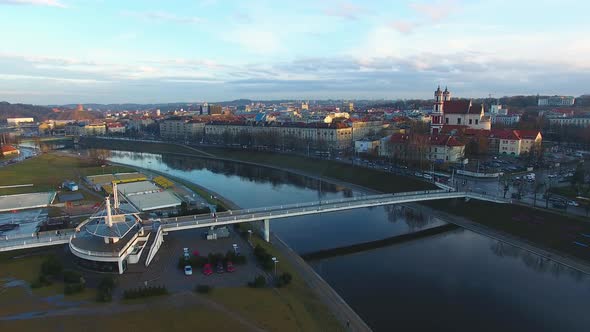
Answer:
(2, 305, 252, 332)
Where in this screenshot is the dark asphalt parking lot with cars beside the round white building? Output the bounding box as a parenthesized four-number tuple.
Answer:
(120, 228, 264, 291)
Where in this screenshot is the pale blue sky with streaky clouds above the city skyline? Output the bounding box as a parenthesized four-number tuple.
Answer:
(0, 0, 590, 104)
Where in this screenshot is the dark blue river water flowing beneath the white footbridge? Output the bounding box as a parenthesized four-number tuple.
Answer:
(103, 151, 590, 331)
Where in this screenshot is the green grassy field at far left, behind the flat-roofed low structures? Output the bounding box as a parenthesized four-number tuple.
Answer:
(0, 153, 133, 195)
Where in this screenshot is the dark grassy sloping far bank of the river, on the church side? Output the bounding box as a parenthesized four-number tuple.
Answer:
(80, 139, 590, 266)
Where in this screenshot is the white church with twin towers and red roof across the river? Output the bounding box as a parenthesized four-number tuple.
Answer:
(430, 86, 492, 135)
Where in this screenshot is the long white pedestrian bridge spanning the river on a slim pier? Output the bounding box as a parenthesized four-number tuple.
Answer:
(0, 190, 510, 252)
